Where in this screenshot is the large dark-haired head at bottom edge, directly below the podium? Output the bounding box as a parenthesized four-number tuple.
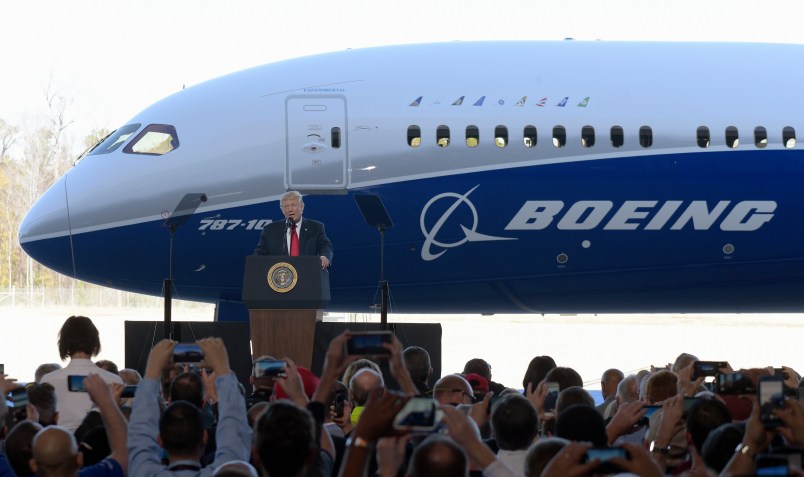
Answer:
(253, 401, 316, 477)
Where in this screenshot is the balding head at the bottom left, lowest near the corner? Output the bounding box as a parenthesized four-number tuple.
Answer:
(29, 426, 84, 477)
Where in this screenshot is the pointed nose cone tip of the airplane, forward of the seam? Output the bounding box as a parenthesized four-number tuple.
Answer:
(18, 175, 75, 276)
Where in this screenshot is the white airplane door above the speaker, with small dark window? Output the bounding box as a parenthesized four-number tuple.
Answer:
(285, 96, 348, 193)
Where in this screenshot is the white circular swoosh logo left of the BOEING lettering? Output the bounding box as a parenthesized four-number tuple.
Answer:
(419, 184, 517, 262)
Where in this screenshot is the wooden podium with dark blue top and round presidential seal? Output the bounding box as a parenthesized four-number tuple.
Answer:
(243, 255, 330, 368)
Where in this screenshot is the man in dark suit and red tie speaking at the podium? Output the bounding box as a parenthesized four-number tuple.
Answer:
(254, 190, 332, 268)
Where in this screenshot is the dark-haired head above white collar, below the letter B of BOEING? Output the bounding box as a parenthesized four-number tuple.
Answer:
(491, 394, 539, 450)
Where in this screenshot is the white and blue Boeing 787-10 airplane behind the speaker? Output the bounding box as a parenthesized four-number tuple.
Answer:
(19, 40, 804, 320)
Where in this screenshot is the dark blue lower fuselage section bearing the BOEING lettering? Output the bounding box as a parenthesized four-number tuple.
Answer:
(24, 150, 804, 313)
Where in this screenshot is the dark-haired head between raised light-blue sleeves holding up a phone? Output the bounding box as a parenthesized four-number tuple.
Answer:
(158, 401, 207, 460)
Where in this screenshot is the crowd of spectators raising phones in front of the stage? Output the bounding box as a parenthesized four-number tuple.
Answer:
(0, 316, 804, 477)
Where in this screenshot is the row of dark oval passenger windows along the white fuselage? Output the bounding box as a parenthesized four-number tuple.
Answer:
(408, 126, 796, 149)
